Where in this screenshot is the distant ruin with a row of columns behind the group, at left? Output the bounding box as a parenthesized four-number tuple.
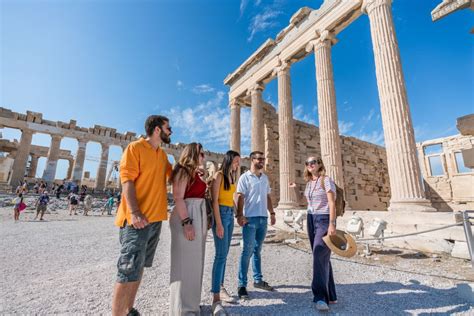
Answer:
(0, 108, 244, 192)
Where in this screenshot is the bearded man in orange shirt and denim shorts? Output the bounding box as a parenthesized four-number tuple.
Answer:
(112, 115, 171, 316)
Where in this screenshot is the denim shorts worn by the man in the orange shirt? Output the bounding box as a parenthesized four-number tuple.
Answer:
(117, 222, 162, 283)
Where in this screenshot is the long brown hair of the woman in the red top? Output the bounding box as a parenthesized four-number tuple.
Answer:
(169, 143, 202, 184)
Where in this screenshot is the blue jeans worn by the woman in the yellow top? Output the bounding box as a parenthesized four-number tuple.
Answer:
(211, 205, 234, 294)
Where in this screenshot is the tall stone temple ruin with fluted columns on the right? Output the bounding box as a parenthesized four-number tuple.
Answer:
(224, 0, 474, 253)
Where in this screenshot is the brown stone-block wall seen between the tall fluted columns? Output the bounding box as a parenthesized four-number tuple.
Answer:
(264, 104, 390, 210)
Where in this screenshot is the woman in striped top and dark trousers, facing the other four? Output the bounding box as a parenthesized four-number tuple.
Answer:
(290, 157, 337, 311)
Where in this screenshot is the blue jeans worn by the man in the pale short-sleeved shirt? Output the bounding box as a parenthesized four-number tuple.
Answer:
(239, 216, 268, 287)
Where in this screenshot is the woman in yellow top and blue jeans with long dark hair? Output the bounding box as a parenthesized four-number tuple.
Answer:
(211, 150, 240, 314)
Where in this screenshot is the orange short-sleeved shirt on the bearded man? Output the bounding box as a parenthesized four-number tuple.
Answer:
(115, 138, 171, 227)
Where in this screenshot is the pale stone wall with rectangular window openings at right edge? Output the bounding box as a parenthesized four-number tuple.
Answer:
(417, 135, 474, 211)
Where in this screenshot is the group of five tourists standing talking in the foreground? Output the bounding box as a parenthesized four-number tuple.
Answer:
(112, 115, 337, 315)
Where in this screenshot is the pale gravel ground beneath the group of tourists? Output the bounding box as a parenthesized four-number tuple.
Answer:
(0, 200, 474, 315)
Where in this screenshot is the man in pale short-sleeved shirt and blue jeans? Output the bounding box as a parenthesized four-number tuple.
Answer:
(236, 151, 276, 299)
